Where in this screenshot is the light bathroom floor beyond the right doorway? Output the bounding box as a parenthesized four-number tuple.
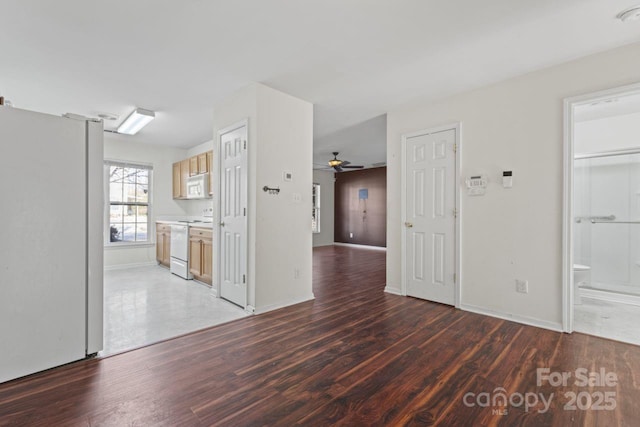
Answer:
(573, 297, 640, 345)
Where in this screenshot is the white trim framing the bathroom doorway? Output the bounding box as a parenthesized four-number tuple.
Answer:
(562, 83, 640, 333)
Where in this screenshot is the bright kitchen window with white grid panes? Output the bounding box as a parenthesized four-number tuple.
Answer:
(104, 161, 153, 245)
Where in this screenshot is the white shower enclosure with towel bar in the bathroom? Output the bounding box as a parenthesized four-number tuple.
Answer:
(573, 148, 640, 296)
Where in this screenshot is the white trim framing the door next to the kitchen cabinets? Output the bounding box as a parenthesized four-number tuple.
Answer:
(212, 117, 253, 312)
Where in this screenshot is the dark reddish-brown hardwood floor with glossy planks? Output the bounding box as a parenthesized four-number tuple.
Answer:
(0, 246, 640, 426)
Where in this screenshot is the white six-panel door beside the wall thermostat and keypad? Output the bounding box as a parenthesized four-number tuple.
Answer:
(404, 129, 456, 305)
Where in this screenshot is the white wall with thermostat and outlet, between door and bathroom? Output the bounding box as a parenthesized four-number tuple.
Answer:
(387, 44, 640, 329)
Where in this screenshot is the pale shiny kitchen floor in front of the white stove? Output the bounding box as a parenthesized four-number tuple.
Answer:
(99, 266, 247, 356)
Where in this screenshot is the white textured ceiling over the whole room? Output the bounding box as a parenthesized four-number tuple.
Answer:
(0, 0, 640, 169)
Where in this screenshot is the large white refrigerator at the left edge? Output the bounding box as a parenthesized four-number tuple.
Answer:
(0, 106, 104, 383)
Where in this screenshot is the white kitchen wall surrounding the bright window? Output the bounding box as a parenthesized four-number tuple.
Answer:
(104, 133, 190, 268)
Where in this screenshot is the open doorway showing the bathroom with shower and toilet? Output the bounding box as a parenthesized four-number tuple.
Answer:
(565, 86, 640, 345)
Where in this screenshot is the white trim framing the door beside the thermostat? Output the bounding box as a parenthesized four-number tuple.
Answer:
(400, 122, 462, 308)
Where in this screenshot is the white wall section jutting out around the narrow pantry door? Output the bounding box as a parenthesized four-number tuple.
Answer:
(214, 84, 313, 313)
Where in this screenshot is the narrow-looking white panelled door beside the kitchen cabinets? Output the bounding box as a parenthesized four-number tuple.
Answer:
(218, 124, 247, 308)
